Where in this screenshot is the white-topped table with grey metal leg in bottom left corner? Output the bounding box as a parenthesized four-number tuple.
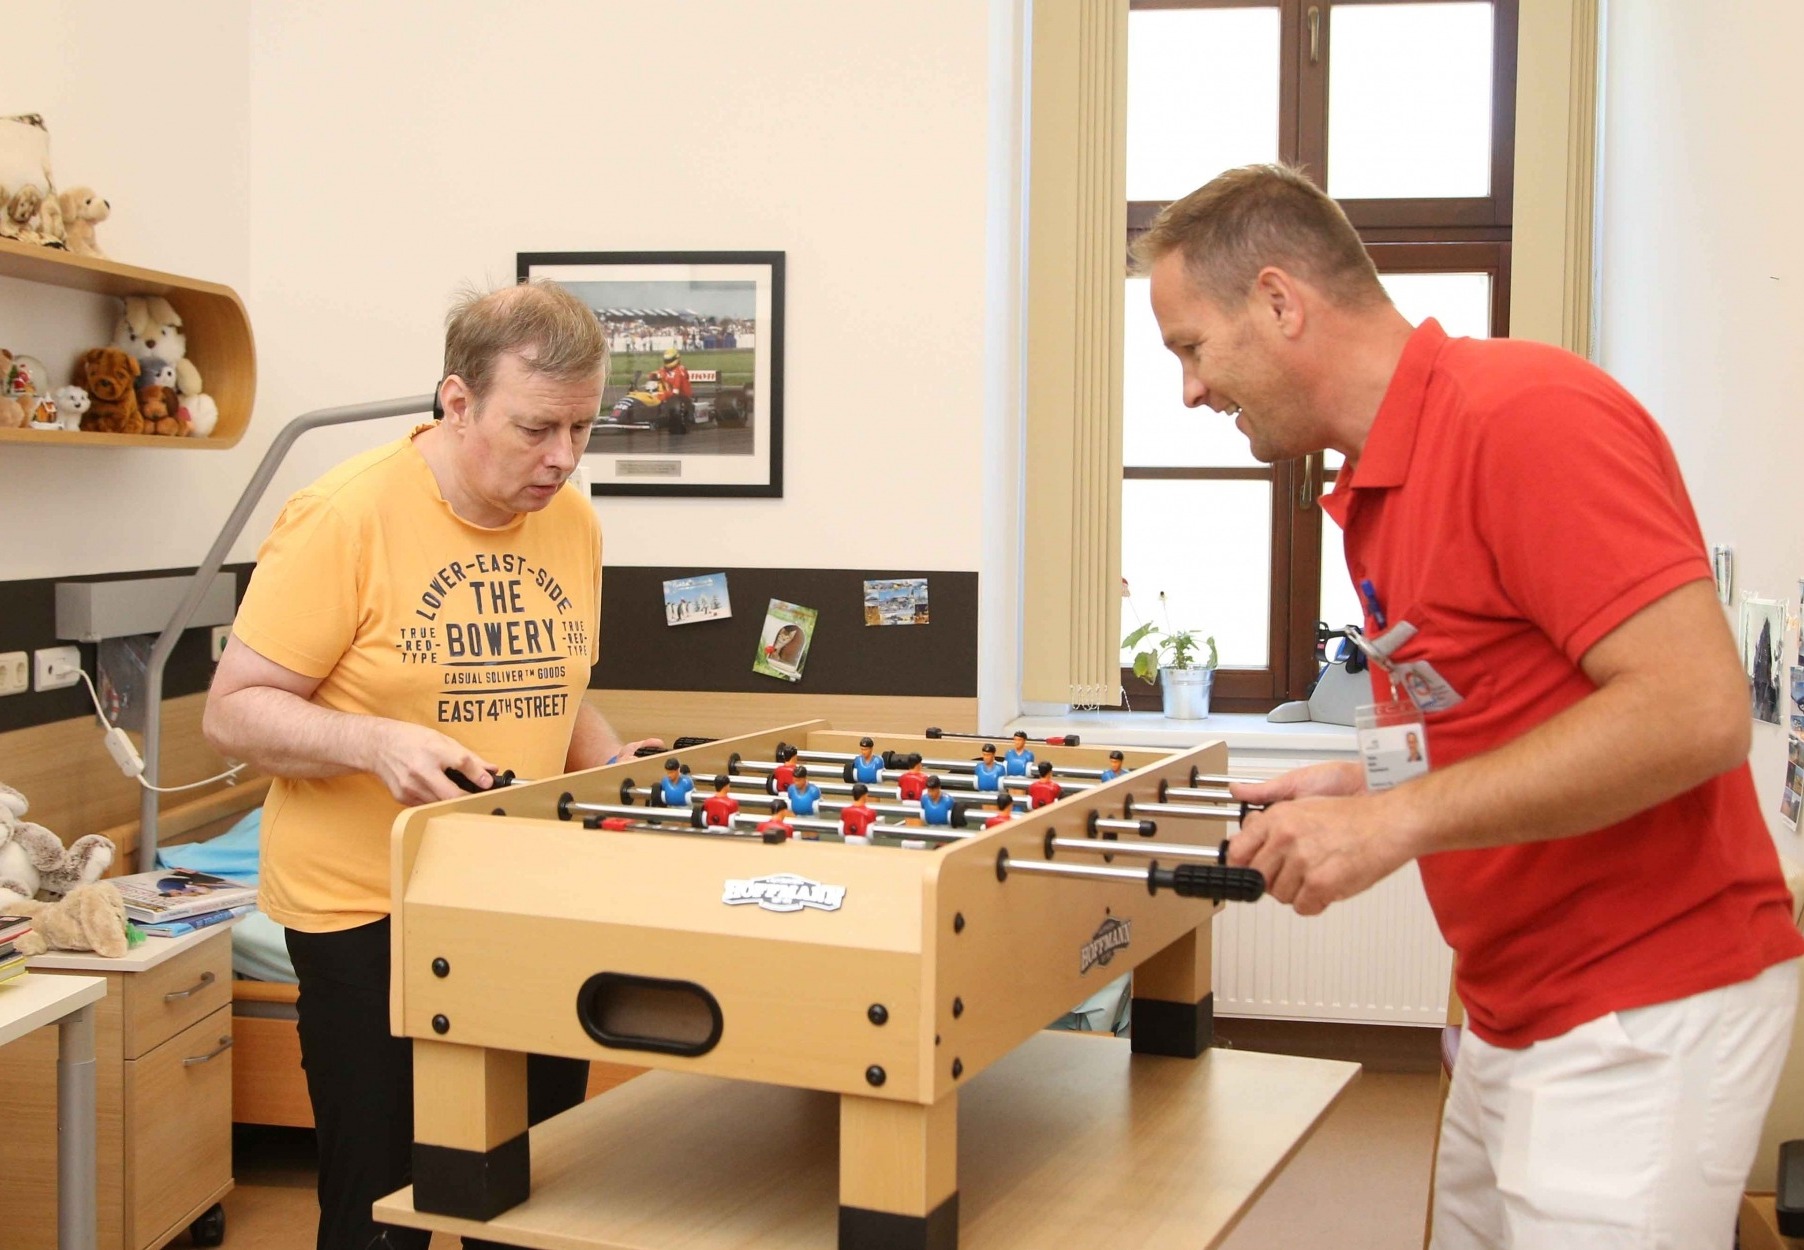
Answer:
(0, 972, 106, 1250)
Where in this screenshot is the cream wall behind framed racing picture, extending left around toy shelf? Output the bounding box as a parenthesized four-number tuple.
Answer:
(0, 0, 1019, 579)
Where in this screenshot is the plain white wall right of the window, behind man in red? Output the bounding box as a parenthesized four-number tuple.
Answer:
(1598, 0, 1804, 855)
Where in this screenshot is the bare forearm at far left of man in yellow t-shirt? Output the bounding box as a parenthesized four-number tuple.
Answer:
(202, 685, 379, 777)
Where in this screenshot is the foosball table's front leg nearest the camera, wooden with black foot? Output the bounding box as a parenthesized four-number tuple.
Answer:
(839, 1091, 958, 1250)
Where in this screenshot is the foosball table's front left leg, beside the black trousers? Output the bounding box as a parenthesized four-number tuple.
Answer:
(413, 1039, 532, 1219)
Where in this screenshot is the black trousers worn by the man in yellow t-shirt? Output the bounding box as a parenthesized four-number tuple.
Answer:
(287, 920, 588, 1250)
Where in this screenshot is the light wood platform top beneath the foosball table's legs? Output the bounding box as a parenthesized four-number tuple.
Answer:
(375, 1034, 1358, 1250)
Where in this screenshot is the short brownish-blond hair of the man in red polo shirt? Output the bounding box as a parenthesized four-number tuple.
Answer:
(1129, 164, 1389, 307)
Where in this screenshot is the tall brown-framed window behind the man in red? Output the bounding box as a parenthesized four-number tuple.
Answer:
(1122, 0, 1517, 711)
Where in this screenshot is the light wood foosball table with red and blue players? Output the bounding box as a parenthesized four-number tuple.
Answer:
(377, 722, 1339, 1250)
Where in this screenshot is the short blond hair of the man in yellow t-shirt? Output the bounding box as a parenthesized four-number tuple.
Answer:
(446, 278, 608, 404)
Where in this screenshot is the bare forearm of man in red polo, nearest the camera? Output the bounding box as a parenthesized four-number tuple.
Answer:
(1373, 663, 1746, 857)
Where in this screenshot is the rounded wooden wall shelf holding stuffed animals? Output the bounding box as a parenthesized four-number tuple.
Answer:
(0, 238, 256, 451)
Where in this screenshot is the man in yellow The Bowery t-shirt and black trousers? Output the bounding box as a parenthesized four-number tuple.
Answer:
(204, 283, 662, 1250)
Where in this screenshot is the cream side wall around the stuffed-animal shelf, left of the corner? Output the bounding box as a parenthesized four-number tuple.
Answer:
(0, 0, 254, 581)
